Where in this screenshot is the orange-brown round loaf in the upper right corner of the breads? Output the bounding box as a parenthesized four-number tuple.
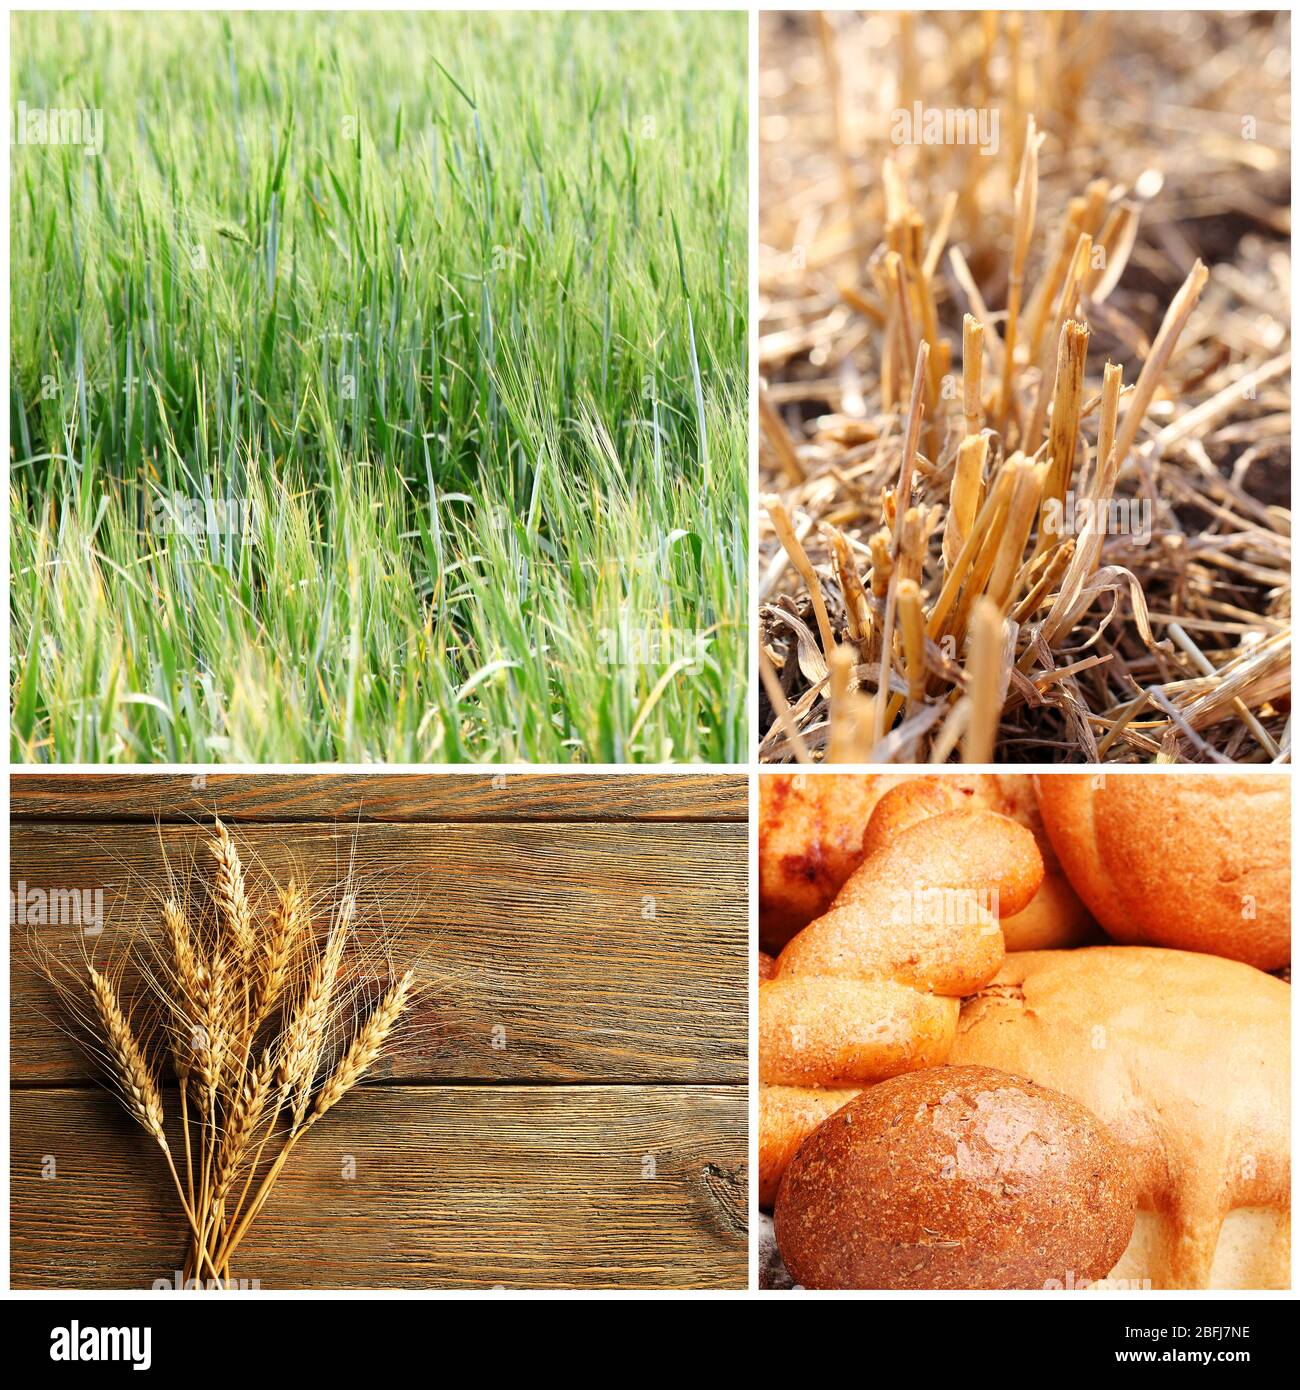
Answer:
(1036, 773, 1290, 970)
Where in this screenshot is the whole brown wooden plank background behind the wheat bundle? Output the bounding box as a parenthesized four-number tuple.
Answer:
(10, 773, 748, 1289)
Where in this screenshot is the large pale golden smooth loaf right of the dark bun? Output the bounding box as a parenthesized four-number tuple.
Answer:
(950, 945, 1290, 1289)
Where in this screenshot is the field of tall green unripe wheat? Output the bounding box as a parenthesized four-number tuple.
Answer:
(10, 13, 748, 762)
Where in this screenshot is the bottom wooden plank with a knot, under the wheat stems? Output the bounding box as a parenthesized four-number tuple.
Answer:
(10, 1086, 747, 1289)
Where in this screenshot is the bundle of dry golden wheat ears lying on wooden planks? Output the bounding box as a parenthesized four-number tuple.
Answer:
(33, 820, 416, 1287)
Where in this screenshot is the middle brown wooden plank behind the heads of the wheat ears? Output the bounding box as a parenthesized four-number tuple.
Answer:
(10, 823, 748, 1084)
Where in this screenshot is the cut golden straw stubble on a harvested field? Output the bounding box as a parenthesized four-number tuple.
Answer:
(759, 14, 1290, 762)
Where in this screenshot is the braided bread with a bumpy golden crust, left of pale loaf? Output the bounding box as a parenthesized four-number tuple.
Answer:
(759, 778, 1043, 1205)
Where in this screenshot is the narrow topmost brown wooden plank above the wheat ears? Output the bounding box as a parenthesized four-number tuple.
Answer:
(10, 771, 748, 823)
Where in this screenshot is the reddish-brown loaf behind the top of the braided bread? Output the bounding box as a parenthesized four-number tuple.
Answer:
(759, 773, 1097, 951)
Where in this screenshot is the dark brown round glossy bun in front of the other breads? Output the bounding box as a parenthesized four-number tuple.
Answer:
(776, 1066, 1136, 1289)
